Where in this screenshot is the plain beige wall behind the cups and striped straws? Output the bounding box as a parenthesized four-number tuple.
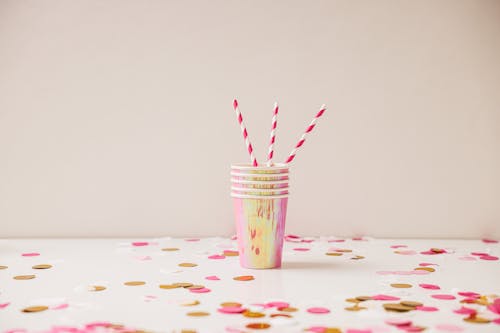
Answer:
(0, 0, 500, 238)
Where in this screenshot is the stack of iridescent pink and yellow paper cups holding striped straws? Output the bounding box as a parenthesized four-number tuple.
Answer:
(231, 163, 289, 268)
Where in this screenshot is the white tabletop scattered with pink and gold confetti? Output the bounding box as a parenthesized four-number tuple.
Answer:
(0, 235, 500, 333)
